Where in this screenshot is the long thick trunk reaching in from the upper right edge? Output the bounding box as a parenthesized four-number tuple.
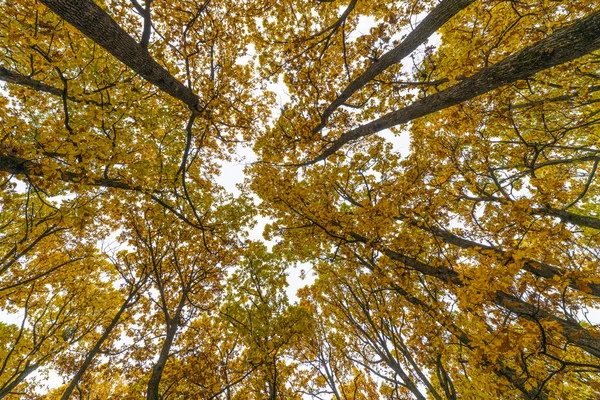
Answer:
(302, 11, 600, 165)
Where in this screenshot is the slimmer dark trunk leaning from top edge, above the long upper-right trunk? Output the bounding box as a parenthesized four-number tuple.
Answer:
(313, 0, 474, 133)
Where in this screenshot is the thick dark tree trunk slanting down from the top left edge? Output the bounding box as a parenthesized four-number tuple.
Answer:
(41, 0, 199, 109)
